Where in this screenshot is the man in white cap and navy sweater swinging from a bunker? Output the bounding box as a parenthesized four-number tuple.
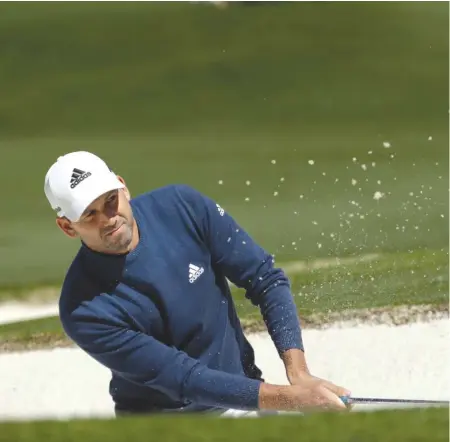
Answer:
(44, 152, 350, 415)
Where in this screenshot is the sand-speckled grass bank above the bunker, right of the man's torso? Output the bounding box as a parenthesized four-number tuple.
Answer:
(236, 250, 449, 318)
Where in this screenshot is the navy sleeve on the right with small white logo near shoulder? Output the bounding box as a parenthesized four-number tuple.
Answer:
(180, 186, 304, 354)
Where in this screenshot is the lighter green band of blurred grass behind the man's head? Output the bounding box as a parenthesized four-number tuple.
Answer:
(0, 128, 448, 288)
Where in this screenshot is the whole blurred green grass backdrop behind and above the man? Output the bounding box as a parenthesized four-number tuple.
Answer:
(0, 2, 449, 288)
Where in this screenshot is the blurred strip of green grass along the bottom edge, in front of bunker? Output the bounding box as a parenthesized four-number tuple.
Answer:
(0, 408, 449, 442)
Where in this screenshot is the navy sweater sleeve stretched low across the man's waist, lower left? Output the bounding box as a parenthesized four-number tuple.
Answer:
(62, 303, 261, 410)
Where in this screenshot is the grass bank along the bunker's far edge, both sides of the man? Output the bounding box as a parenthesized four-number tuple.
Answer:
(0, 250, 449, 350)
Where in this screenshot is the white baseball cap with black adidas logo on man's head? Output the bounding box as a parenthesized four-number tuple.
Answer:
(44, 151, 125, 221)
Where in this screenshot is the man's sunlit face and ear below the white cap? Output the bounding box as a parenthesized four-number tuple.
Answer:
(57, 177, 137, 253)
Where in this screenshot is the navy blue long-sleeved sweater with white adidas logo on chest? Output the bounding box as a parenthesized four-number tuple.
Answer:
(60, 185, 303, 411)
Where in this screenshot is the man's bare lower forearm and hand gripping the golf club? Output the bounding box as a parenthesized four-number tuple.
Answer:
(259, 376, 349, 411)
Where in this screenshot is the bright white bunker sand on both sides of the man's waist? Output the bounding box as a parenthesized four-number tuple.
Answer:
(0, 319, 450, 419)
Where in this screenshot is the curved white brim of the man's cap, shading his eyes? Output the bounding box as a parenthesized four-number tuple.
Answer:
(66, 172, 125, 221)
